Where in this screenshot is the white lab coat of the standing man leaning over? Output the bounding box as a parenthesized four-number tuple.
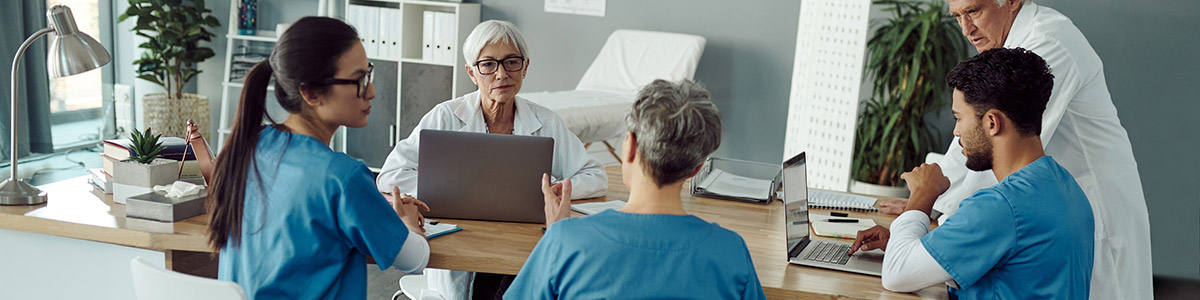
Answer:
(934, 2, 1153, 299)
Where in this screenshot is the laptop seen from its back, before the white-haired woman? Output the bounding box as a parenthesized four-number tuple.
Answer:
(416, 130, 554, 223)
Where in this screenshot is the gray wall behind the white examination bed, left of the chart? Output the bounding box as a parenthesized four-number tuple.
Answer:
(481, 0, 800, 162)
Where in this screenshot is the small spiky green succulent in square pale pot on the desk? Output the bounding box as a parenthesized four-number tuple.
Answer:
(113, 127, 179, 203)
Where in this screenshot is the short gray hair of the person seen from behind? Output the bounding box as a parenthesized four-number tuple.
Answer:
(625, 79, 721, 187)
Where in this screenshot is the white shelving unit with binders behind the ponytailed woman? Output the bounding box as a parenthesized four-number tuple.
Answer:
(216, 0, 480, 172)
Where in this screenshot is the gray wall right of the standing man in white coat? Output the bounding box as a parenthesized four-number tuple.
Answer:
(1038, 0, 1200, 280)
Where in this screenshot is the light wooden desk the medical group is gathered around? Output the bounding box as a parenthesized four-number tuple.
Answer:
(0, 167, 946, 299)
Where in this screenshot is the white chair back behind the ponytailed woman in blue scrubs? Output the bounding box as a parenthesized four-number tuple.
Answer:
(130, 257, 246, 300)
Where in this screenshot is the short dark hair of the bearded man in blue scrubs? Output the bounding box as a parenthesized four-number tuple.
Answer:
(946, 48, 1054, 137)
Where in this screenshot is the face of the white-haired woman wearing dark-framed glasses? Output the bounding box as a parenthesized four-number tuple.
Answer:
(467, 42, 529, 103)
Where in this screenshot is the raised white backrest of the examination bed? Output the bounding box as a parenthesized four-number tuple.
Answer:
(575, 29, 704, 95)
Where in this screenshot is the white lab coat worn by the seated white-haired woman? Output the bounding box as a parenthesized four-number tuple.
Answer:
(376, 91, 608, 199)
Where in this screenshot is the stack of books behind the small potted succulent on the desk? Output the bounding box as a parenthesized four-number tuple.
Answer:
(89, 137, 204, 193)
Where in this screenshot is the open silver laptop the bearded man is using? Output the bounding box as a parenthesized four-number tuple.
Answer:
(784, 152, 883, 276)
